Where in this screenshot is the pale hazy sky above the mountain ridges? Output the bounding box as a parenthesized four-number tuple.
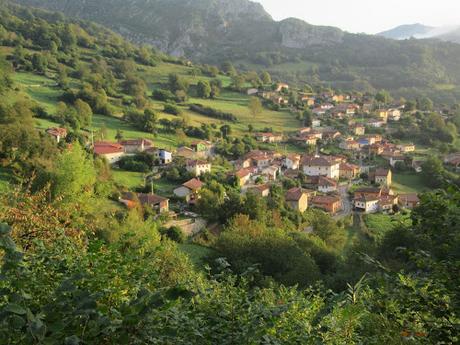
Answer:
(253, 0, 460, 33)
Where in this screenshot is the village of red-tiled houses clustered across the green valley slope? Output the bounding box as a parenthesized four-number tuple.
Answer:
(42, 83, 460, 231)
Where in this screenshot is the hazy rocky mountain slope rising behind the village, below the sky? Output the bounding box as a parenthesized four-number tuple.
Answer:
(10, 0, 460, 103)
